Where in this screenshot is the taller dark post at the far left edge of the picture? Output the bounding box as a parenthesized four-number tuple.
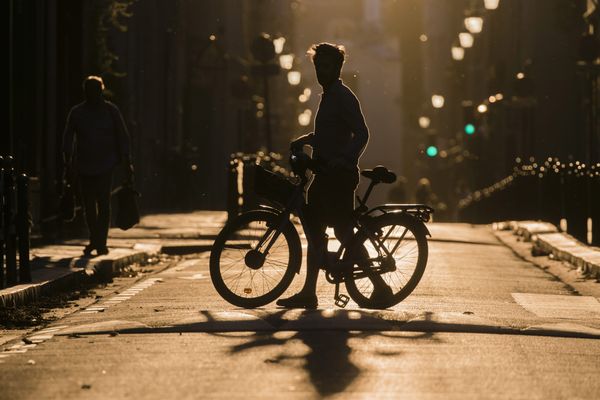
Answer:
(3, 156, 17, 286)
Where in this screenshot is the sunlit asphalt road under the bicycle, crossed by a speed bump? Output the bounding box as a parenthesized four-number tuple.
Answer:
(0, 224, 600, 399)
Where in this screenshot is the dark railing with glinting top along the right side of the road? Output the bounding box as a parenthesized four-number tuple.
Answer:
(459, 158, 600, 245)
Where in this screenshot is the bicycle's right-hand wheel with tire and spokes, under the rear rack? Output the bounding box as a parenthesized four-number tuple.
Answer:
(344, 213, 428, 309)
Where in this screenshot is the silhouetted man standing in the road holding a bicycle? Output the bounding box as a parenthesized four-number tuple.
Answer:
(277, 43, 389, 308)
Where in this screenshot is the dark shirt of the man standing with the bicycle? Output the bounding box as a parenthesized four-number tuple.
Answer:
(311, 79, 369, 165)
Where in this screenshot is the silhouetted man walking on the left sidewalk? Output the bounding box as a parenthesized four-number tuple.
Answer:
(63, 76, 133, 257)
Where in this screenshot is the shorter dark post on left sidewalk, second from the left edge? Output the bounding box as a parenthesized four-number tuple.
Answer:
(16, 174, 31, 283)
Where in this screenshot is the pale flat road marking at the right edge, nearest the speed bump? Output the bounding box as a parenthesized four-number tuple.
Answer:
(511, 293, 600, 319)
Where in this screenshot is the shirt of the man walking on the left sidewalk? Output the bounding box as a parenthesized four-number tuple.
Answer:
(63, 101, 129, 175)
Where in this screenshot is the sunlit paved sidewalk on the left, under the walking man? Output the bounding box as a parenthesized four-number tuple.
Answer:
(0, 211, 227, 306)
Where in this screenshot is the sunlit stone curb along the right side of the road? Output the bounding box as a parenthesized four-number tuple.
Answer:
(494, 221, 600, 279)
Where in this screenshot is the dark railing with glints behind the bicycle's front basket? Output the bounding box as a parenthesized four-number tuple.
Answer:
(227, 152, 289, 218)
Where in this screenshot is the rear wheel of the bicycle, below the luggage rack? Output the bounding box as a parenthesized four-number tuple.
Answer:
(344, 214, 428, 309)
